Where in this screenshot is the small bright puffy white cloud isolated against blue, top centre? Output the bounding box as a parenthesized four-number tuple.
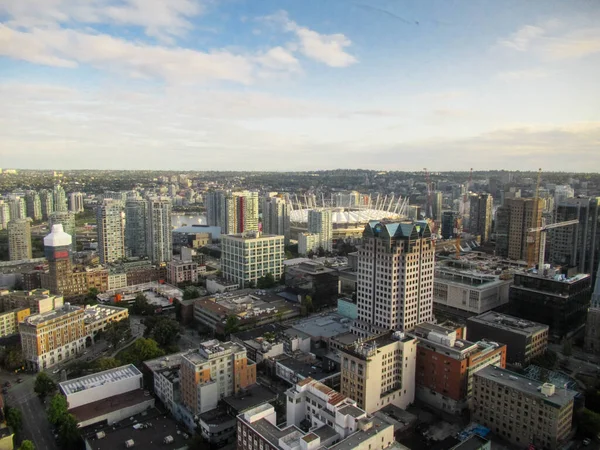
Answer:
(262, 11, 357, 67)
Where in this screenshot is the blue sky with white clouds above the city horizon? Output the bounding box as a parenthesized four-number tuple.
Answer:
(0, 0, 600, 172)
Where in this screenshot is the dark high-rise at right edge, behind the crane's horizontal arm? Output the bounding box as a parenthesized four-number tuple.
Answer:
(548, 197, 600, 274)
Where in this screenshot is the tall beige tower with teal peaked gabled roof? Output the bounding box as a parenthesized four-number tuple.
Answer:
(354, 221, 435, 334)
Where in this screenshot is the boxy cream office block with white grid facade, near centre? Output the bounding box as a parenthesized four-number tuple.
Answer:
(221, 232, 285, 288)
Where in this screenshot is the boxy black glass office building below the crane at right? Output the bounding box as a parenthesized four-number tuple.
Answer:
(509, 270, 592, 341)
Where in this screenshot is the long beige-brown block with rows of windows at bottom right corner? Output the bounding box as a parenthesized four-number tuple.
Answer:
(471, 367, 577, 450)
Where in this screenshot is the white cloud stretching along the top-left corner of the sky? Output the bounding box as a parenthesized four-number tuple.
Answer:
(0, 0, 203, 41)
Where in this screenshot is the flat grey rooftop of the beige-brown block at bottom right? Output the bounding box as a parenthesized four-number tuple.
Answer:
(475, 366, 577, 407)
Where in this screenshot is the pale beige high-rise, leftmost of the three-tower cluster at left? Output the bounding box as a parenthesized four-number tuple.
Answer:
(96, 199, 125, 264)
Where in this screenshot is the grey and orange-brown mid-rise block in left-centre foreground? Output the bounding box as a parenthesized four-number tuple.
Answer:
(179, 340, 256, 414)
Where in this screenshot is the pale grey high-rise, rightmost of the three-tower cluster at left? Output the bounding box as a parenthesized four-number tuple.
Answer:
(146, 197, 173, 263)
